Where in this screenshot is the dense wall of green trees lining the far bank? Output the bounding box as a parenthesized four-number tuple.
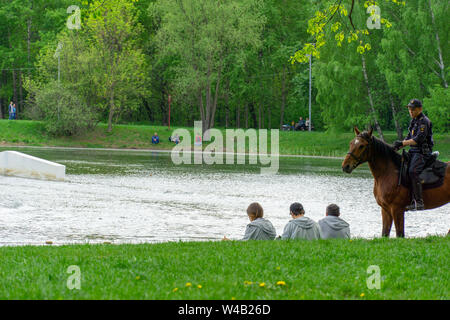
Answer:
(0, 0, 450, 131)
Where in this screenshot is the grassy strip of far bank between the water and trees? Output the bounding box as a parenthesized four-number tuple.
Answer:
(0, 120, 450, 161)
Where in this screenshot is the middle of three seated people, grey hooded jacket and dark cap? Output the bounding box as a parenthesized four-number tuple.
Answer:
(281, 202, 320, 240)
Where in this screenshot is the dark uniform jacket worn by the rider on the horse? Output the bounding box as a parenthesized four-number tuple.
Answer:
(406, 113, 434, 155)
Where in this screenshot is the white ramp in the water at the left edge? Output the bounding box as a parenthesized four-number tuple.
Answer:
(0, 151, 66, 180)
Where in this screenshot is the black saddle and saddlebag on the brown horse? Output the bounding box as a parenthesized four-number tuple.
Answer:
(399, 150, 447, 190)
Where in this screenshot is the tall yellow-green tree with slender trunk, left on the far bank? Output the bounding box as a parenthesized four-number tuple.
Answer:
(86, 0, 145, 132)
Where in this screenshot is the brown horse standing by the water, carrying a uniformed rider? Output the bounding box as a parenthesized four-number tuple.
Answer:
(342, 127, 450, 237)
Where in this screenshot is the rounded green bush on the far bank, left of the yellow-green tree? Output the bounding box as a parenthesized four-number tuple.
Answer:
(29, 82, 96, 136)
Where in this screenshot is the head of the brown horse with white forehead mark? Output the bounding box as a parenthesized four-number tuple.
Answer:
(342, 126, 373, 173)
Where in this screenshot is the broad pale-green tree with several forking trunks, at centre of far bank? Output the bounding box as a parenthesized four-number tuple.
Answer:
(156, 0, 265, 130)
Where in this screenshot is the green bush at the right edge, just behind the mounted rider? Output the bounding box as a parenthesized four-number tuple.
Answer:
(423, 86, 450, 133)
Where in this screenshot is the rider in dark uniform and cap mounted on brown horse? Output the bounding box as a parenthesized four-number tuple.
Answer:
(394, 99, 434, 210)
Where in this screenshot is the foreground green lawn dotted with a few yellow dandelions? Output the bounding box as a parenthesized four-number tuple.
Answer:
(0, 236, 450, 300)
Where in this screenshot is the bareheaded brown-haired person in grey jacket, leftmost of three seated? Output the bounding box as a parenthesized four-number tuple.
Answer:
(223, 202, 277, 240)
